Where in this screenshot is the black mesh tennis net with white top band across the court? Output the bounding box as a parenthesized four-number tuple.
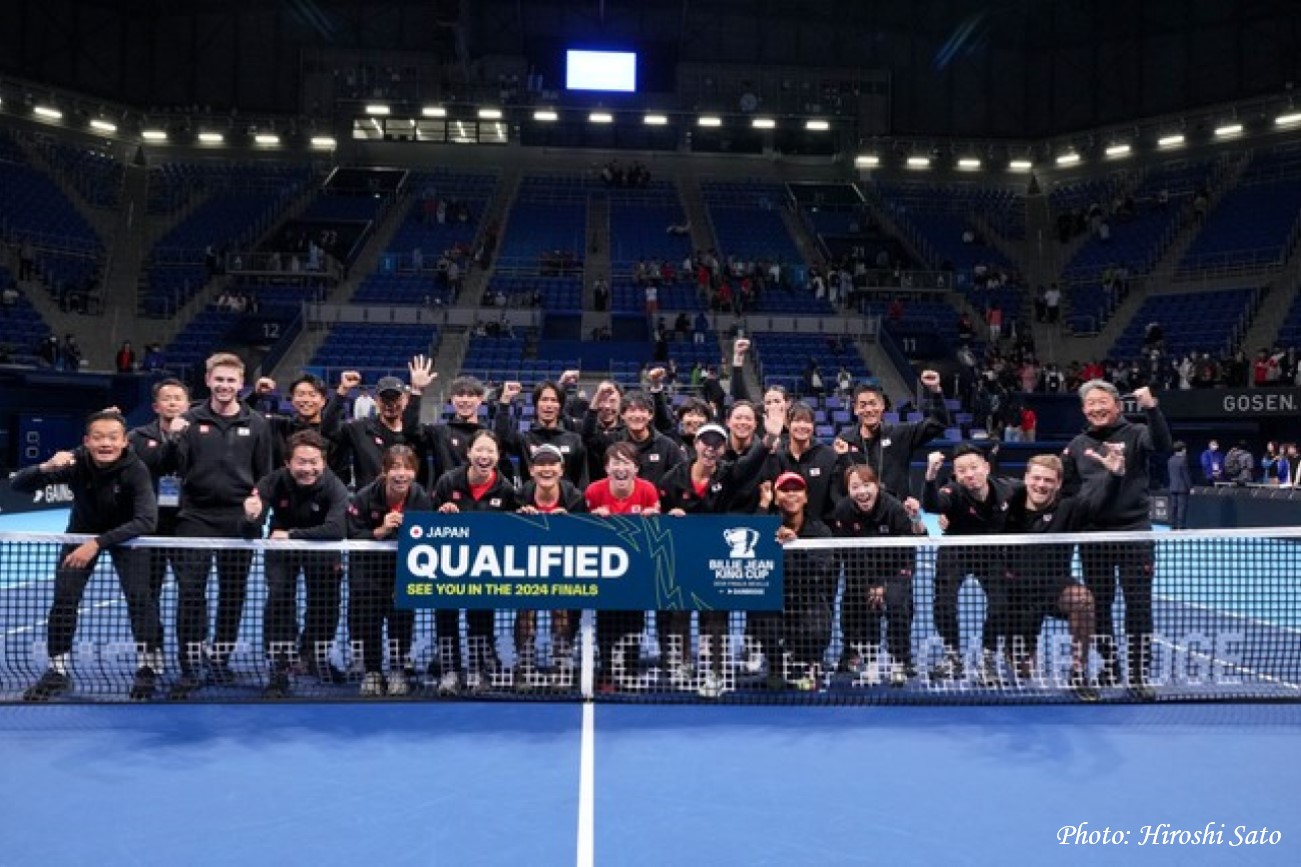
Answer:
(0, 529, 1301, 704)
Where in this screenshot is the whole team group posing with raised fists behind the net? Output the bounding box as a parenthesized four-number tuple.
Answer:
(12, 338, 1170, 700)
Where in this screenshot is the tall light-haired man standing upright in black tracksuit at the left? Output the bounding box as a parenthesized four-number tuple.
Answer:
(172, 353, 275, 699)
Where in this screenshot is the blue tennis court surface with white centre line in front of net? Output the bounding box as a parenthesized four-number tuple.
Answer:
(0, 513, 1301, 866)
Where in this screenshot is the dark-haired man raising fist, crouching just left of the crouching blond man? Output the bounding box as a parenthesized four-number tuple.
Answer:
(921, 443, 1021, 686)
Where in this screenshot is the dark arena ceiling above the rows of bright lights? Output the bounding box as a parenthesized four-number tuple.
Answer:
(0, 0, 1301, 137)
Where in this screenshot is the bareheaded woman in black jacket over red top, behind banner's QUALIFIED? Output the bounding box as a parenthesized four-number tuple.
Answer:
(433, 428, 519, 695)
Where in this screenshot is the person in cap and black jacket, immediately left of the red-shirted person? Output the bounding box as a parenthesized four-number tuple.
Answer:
(515, 443, 587, 689)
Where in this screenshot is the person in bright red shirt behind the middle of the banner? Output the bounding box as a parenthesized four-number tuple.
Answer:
(587, 441, 660, 693)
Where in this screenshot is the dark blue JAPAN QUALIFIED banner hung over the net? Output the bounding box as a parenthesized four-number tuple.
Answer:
(396, 512, 782, 611)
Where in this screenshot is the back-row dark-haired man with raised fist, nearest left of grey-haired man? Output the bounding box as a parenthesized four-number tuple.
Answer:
(835, 370, 948, 514)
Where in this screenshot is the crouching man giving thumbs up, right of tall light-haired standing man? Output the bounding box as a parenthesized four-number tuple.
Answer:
(243, 431, 349, 698)
